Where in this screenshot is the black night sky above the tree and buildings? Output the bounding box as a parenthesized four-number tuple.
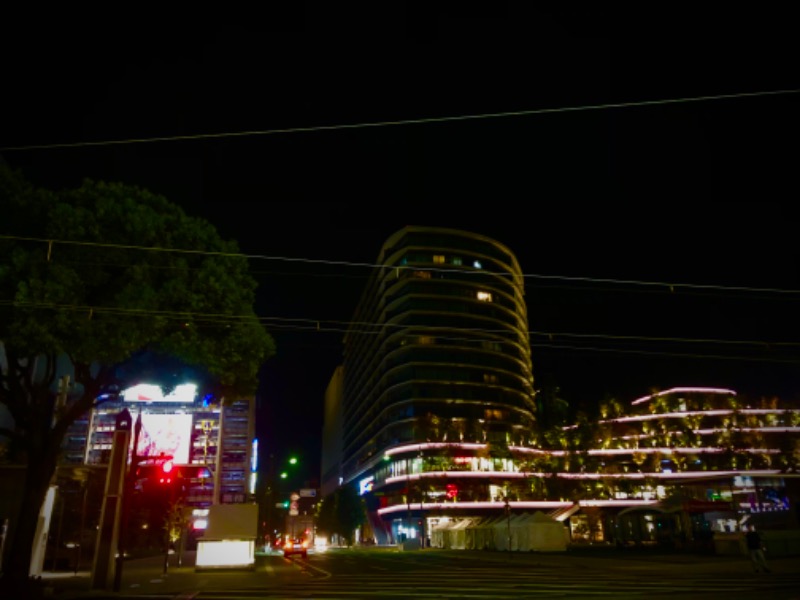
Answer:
(0, 1, 800, 477)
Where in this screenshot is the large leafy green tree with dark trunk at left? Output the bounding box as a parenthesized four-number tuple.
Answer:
(0, 166, 275, 587)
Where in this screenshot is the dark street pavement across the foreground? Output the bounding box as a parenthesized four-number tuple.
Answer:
(20, 546, 800, 600)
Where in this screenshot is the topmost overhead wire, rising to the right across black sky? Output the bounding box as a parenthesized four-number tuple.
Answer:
(0, 89, 800, 152)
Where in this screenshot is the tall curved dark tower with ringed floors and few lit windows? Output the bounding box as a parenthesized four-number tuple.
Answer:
(323, 226, 535, 538)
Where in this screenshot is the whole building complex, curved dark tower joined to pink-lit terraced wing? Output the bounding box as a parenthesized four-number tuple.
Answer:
(322, 227, 800, 543)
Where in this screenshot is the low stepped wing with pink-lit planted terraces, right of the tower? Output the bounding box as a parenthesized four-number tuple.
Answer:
(576, 387, 800, 542)
